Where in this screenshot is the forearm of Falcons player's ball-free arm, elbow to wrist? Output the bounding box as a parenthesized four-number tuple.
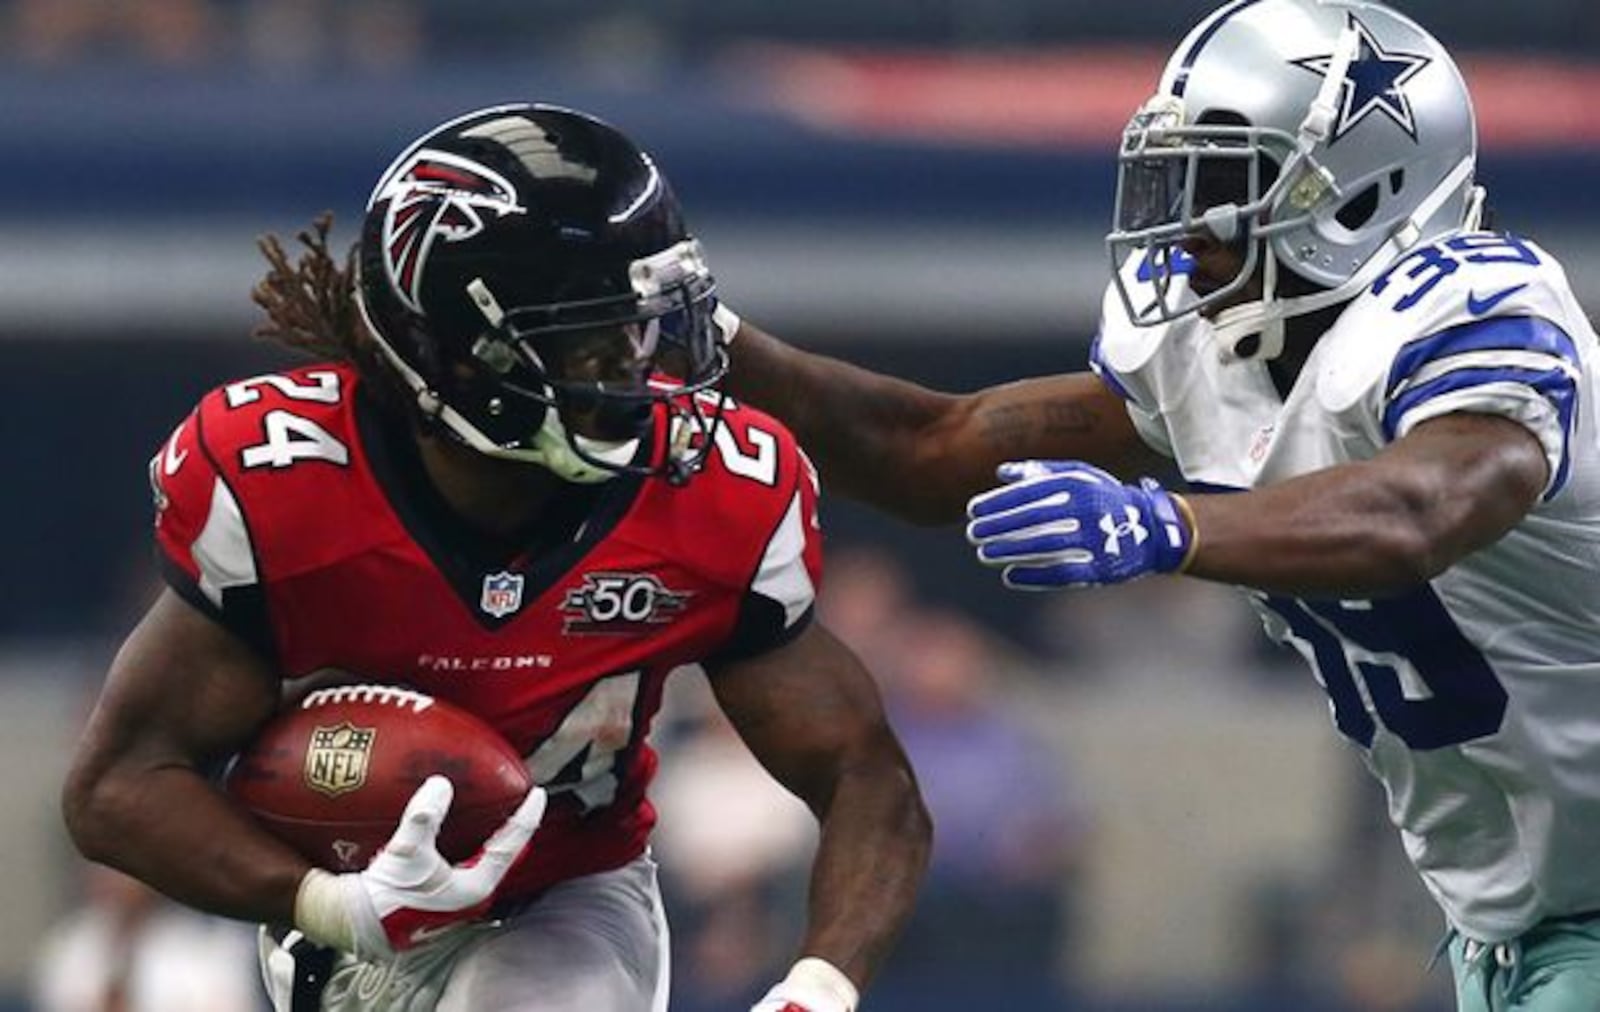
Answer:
(802, 759, 933, 986)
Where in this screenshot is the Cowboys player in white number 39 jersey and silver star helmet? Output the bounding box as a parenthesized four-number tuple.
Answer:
(720, 0, 1600, 1012)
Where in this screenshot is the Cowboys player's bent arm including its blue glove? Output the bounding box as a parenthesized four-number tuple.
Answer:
(966, 413, 1549, 597)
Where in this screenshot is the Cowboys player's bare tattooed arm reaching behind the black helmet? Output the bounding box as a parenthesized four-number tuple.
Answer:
(728, 322, 1150, 524)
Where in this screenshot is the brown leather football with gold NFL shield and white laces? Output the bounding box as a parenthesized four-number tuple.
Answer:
(224, 685, 533, 871)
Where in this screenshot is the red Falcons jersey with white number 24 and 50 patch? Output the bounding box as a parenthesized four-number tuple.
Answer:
(150, 365, 821, 897)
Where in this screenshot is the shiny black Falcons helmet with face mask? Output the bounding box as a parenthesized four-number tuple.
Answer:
(358, 104, 728, 482)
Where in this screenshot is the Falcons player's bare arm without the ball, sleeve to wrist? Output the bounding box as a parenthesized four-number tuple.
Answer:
(710, 623, 933, 1012)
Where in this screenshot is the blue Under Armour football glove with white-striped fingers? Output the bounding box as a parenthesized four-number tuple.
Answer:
(966, 460, 1194, 591)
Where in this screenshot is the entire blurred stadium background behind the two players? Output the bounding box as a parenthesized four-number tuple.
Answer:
(0, 0, 1600, 1012)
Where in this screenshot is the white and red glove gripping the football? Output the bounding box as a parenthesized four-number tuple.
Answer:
(294, 777, 546, 959)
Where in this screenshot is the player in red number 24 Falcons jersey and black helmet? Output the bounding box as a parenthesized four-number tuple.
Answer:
(64, 106, 930, 1012)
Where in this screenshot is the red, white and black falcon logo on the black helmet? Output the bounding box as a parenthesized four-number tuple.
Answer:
(373, 147, 528, 312)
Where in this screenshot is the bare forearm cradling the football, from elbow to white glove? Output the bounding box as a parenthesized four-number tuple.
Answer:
(66, 765, 309, 924)
